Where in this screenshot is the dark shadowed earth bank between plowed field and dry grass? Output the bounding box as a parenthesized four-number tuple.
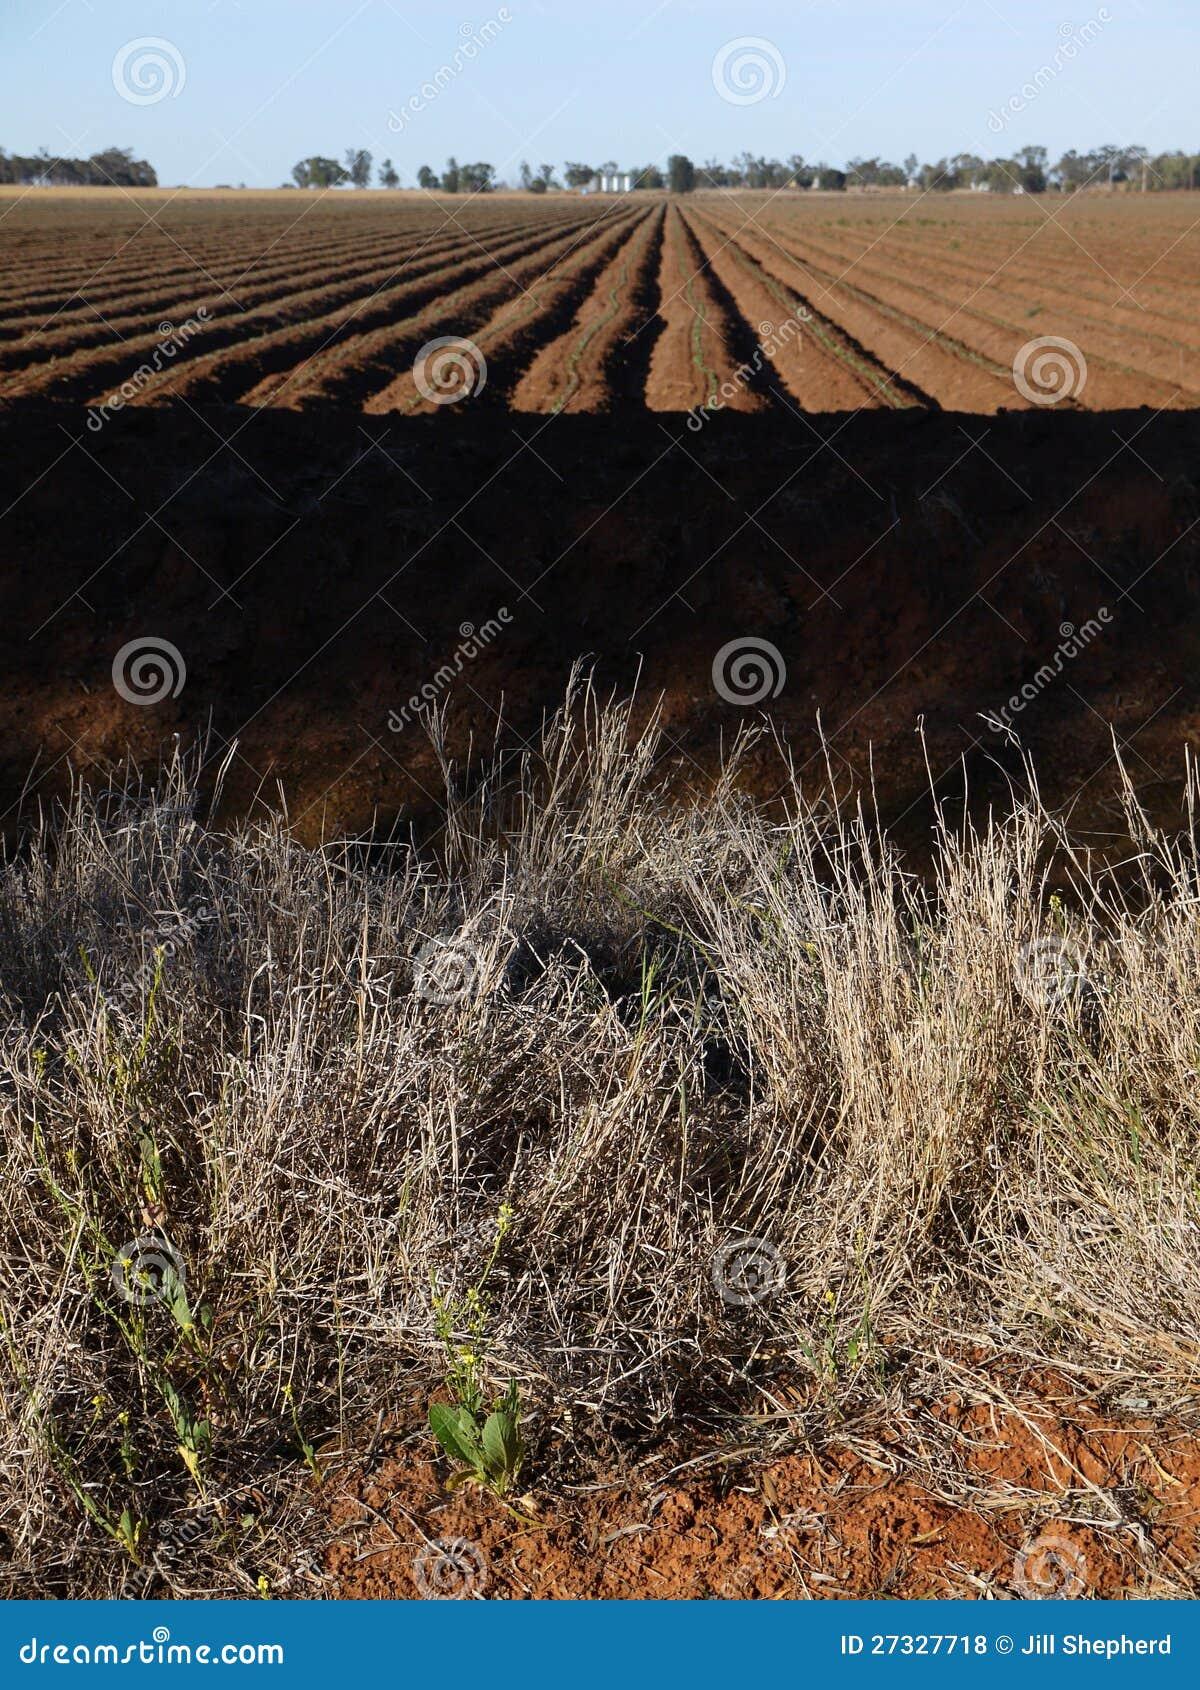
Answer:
(0, 404, 1200, 851)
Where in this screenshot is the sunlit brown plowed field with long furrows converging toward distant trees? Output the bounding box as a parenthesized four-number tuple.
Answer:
(0, 191, 1200, 414)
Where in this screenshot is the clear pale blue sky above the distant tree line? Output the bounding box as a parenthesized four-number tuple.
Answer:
(0, 0, 1200, 188)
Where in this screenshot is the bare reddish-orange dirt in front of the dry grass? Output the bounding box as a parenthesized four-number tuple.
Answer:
(326, 1377, 1200, 1599)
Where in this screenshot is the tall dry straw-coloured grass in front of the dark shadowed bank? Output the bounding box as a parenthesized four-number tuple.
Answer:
(0, 676, 1200, 1595)
